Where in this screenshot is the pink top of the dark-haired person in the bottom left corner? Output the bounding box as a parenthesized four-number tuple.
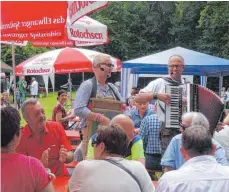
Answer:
(1, 153, 50, 192)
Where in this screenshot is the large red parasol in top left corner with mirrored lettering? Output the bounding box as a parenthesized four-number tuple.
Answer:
(1, 1, 108, 40)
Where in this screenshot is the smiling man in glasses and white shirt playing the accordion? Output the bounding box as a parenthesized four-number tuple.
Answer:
(135, 55, 185, 154)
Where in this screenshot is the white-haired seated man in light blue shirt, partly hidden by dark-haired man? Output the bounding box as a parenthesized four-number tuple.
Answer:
(161, 112, 227, 172)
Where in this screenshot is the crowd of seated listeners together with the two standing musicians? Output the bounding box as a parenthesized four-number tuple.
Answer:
(1, 55, 229, 192)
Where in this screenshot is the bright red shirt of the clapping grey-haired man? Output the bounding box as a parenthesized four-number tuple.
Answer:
(16, 121, 72, 176)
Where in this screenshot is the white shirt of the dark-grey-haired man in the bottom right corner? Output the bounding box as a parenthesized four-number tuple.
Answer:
(156, 155, 229, 192)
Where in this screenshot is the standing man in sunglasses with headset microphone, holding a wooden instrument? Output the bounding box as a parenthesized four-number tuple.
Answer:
(74, 54, 122, 158)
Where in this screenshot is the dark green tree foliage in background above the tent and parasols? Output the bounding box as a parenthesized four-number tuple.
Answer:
(1, 1, 229, 87)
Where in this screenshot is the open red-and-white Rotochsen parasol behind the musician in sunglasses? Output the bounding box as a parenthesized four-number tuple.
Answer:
(16, 47, 121, 75)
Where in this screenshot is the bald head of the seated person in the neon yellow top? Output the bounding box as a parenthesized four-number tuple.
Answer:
(110, 114, 134, 140)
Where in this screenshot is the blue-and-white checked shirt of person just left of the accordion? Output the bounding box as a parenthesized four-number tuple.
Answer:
(139, 114, 161, 154)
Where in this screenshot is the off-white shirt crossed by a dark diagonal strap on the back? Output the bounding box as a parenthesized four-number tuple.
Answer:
(69, 158, 155, 192)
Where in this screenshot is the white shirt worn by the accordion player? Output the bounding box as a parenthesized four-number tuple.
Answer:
(140, 78, 186, 122)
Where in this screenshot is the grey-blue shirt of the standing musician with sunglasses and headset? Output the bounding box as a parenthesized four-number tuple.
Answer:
(74, 79, 122, 129)
